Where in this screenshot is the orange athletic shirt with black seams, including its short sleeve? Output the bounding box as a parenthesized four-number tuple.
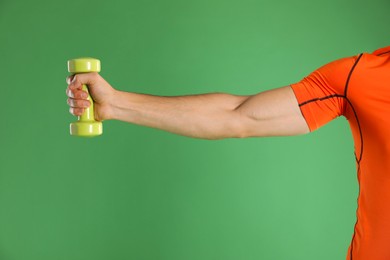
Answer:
(291, 46, 390, 260)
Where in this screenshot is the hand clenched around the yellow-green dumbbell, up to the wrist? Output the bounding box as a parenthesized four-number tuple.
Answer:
(66, 72, 116, 121)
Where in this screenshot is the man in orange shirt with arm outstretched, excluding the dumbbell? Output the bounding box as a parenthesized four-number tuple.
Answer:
(66, 46, 390, 260)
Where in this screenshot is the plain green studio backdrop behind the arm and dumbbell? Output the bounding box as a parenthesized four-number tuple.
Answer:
(0, 0, 390, 260)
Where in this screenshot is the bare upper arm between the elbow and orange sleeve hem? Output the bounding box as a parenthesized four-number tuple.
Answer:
(235, 86, 309, 137)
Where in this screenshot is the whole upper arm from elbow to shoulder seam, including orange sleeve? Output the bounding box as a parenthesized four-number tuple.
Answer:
(236, 56, 359, 136)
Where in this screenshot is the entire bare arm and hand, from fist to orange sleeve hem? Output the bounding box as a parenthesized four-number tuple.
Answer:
(66, 73, 309, 140)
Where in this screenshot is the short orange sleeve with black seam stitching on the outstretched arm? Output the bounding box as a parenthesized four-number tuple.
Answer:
(291, 56, 357, 131)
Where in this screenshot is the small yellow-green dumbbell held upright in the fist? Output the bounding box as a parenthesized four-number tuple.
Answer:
(68, 58, 103, 137)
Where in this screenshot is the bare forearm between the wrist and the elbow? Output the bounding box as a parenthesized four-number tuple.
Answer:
(112, 91, 248, 139)
